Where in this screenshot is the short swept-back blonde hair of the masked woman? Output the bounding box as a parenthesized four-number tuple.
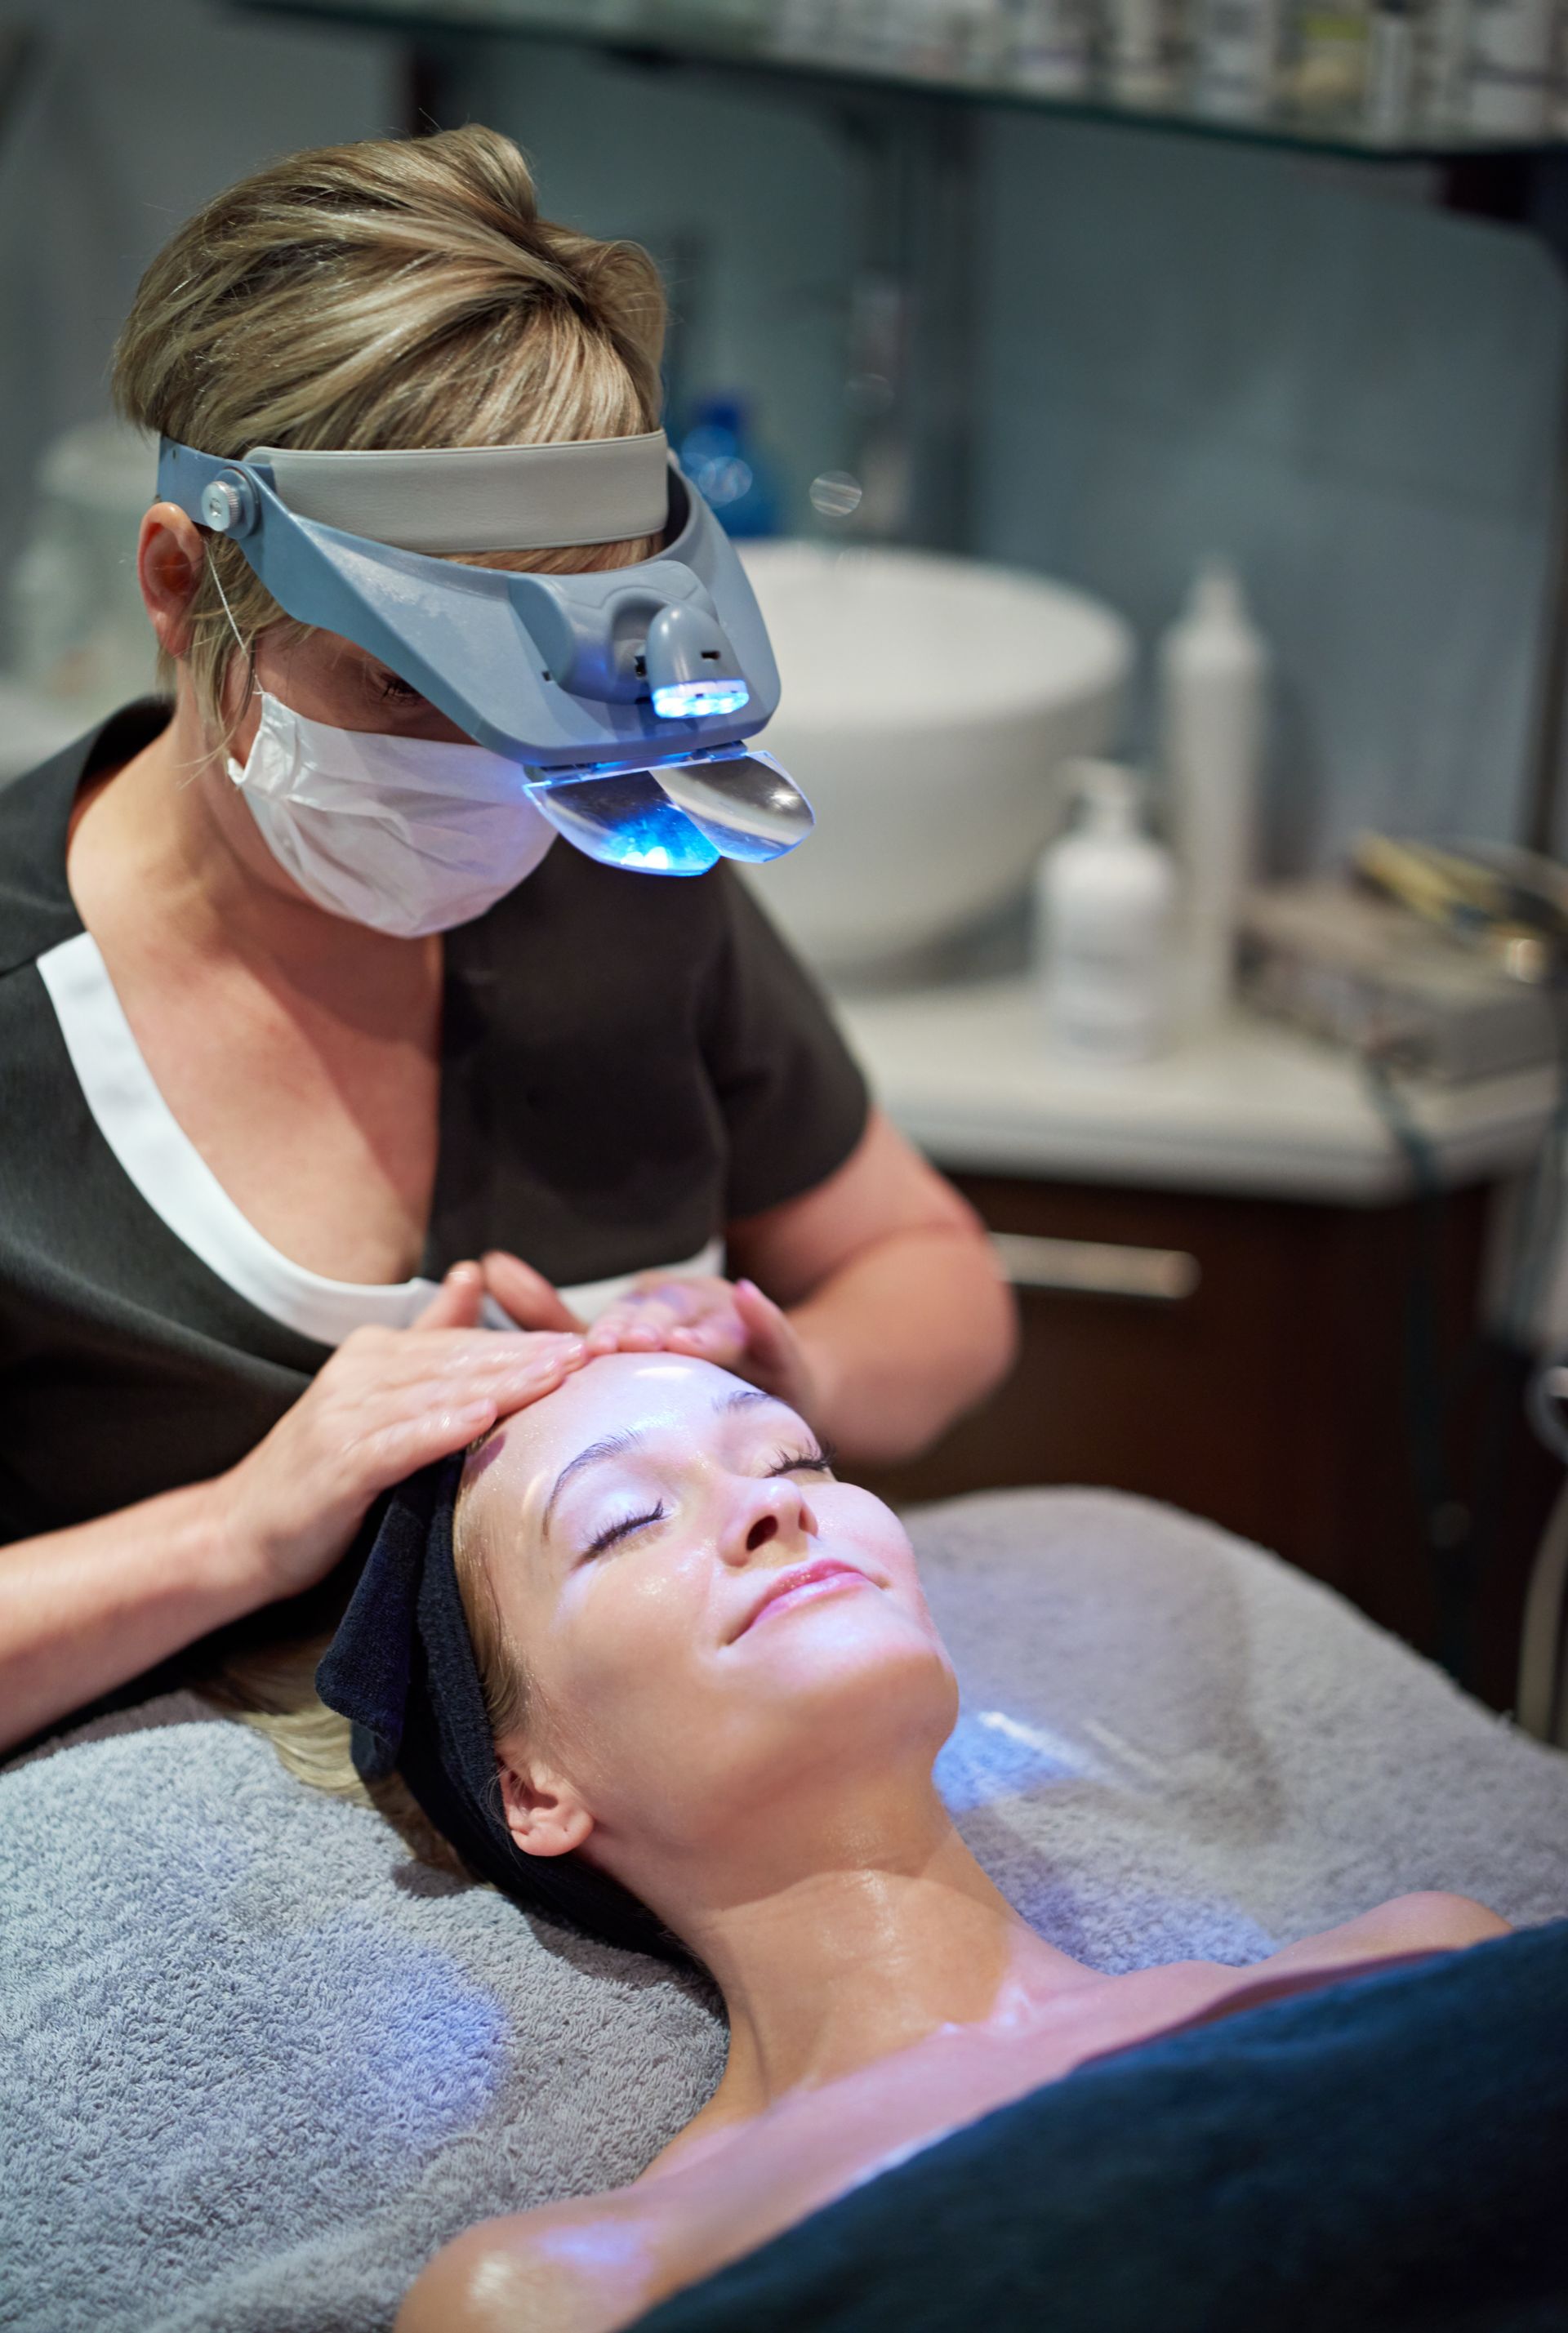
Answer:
(114, 123, 665, 735)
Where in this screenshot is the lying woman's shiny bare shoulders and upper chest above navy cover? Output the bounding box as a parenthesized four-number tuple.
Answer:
(397, 1894, 1508, 2333)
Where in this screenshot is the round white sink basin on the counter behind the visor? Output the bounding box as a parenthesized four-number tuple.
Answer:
(742, 541, 1132, 973)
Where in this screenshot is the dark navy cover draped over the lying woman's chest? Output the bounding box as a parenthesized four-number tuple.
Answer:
(635, 1920, 1568, 2333)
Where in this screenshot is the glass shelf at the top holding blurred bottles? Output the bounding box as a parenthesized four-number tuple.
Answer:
(240, 0, 1568, 163)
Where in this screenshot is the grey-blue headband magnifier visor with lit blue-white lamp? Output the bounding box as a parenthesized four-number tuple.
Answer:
(158, 430, 812, 875)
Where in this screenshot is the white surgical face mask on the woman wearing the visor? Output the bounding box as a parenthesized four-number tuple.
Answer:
(229, 691, 555, 940)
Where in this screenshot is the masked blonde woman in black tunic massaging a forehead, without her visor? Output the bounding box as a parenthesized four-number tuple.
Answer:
(0, 128, 1013, 1745)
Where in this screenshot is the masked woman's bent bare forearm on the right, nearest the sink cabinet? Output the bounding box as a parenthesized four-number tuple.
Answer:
(789, 1225, 1018, 1465)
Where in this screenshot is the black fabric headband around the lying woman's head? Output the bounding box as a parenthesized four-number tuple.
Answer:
(315, 1454, 686, 1960)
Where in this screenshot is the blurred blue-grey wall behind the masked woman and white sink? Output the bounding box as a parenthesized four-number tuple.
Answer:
(0, 0, 1568, 870)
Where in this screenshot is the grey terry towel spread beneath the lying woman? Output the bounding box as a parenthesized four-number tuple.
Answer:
(0, 1491, 1568, 2333)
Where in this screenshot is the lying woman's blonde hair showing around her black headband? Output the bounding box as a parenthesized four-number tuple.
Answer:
(217, 1444, 530, 1876)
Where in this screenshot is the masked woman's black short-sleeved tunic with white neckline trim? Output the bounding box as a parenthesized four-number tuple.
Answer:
(0, 702, 866, 1542)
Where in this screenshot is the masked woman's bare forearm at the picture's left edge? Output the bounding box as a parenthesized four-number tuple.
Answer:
(0, 1484, 266, 1750)
